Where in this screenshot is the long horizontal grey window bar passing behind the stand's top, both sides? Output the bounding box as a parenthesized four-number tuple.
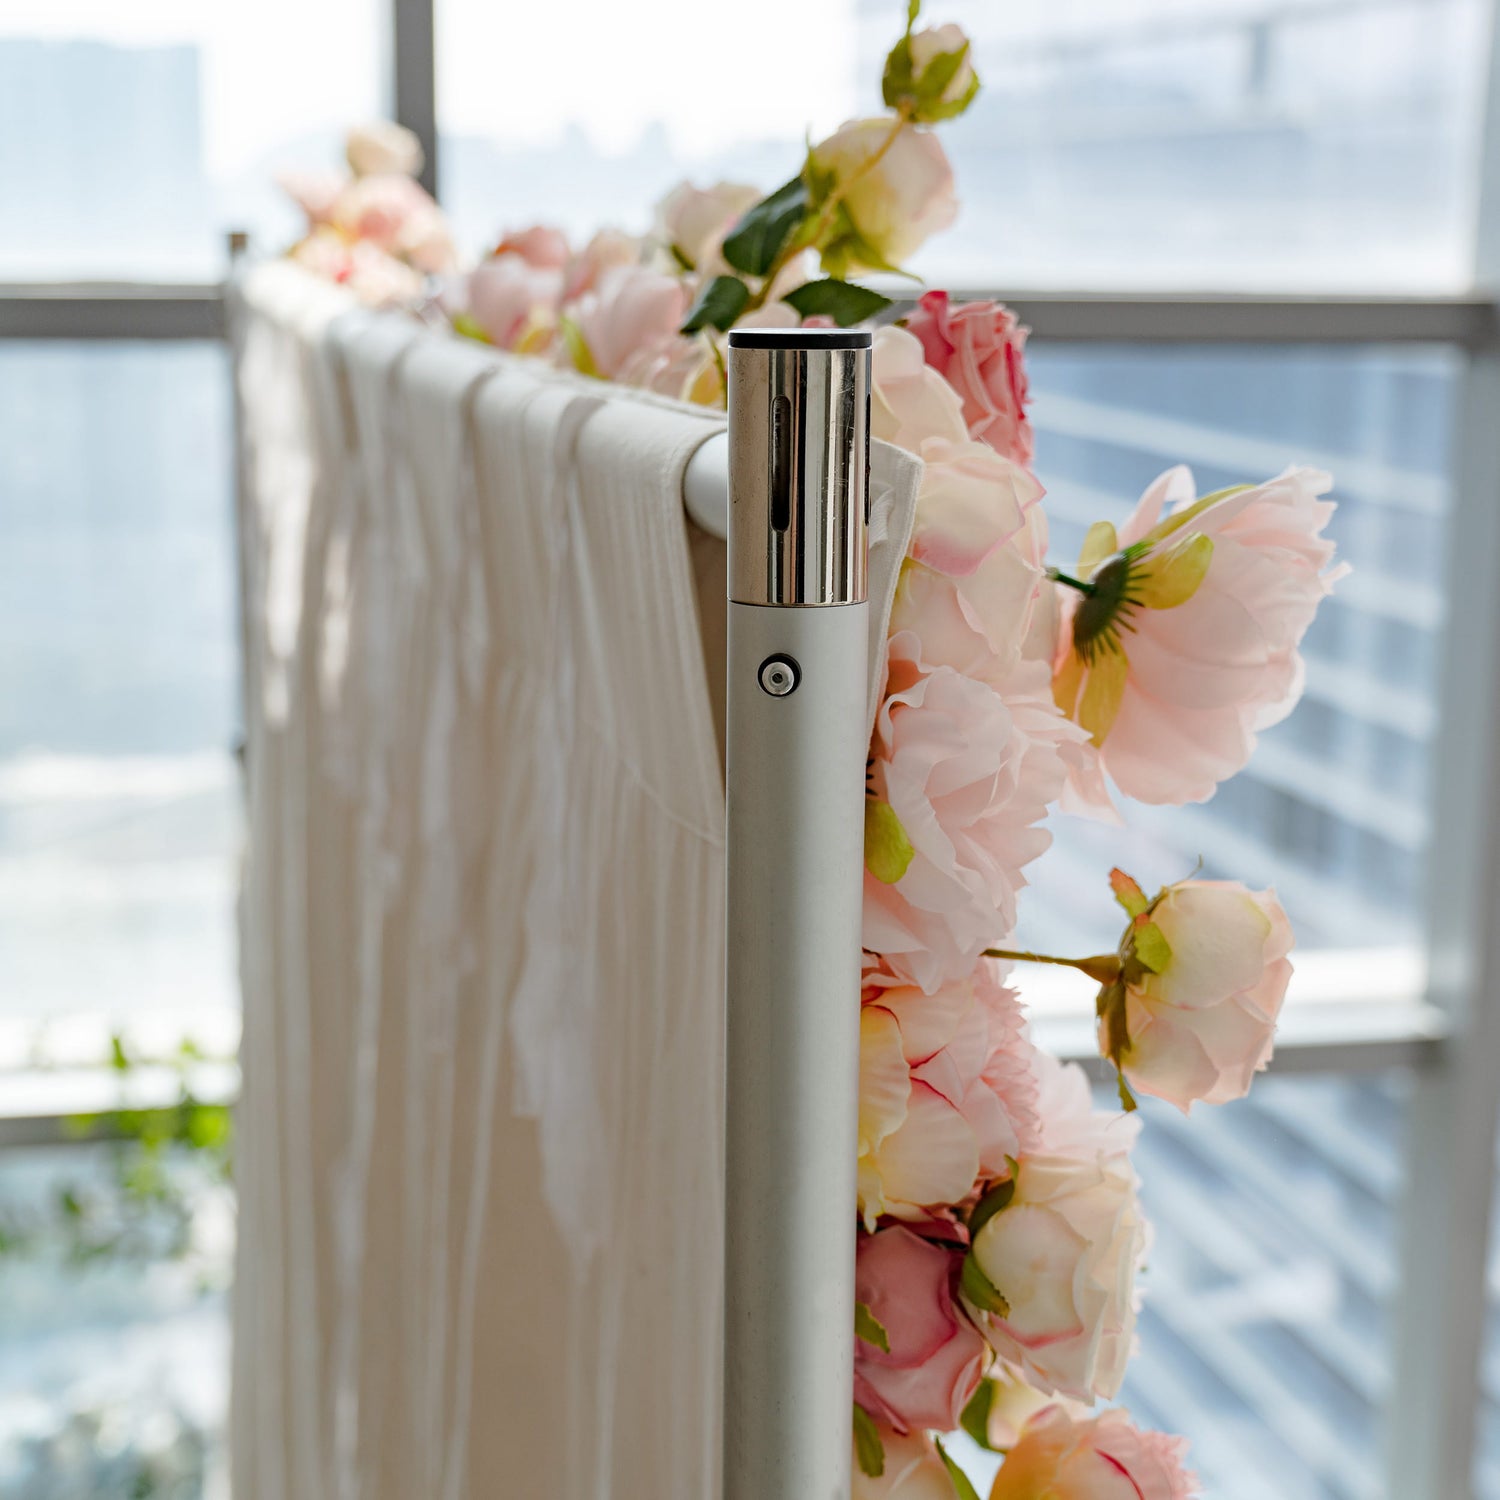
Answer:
(0, 282, 1500, 350)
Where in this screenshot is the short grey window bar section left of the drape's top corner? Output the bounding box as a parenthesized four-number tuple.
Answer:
(0, 282, 225, 341)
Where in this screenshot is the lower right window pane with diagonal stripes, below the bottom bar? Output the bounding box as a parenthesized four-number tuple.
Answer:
(956, 1073, 1410, 1500)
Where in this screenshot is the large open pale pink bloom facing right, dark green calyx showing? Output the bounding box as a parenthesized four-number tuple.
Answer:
(1053, 468, 1346, 804)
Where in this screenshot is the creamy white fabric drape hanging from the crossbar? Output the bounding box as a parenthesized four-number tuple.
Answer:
(231, 264, 918, 1500)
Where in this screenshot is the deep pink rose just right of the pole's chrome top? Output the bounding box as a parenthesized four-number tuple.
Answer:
(906, 291, 1034, 465)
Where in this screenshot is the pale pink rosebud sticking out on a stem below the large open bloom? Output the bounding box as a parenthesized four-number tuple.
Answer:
(1100, 870, 1292, 1113)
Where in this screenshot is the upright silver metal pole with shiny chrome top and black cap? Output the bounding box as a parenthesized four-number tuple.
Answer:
(725, 329, 870, 1500)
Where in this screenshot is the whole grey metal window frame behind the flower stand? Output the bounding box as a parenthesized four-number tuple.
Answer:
(0, 0, 1500, 1496)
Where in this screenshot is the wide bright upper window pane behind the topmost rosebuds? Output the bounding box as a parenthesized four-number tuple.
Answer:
(438, 0, 1488, 290)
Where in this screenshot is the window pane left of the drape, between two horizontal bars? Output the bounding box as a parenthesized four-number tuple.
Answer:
(0, 344, 239, 1022)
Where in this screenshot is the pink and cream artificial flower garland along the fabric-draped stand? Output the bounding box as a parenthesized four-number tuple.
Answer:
(282, 0, 1340, 1500)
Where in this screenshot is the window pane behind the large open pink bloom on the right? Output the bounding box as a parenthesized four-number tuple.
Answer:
(1022, 339, 1457, 972)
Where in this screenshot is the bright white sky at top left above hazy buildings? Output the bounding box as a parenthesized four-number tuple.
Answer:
(0, 0, 864, 177)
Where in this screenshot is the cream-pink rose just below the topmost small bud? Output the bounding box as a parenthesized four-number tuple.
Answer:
(812, 116, 959, 275)
